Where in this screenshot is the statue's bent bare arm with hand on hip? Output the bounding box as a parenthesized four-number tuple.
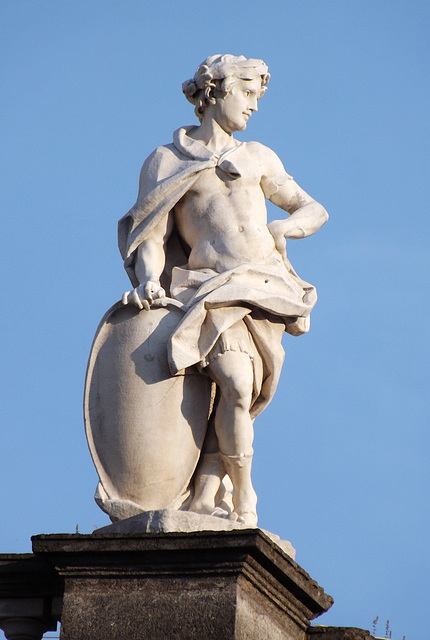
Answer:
(260, 147, 328, 253)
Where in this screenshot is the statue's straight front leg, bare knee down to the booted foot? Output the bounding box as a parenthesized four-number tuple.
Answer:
(206, 351, 257, 526)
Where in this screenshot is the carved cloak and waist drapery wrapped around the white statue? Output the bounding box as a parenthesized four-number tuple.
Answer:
(118, 128, 317, 417)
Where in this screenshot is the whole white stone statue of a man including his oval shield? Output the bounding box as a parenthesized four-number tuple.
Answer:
(85, 55, 328, 527)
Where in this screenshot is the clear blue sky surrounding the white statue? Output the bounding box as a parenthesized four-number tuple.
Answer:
(0, 0, 430, 640)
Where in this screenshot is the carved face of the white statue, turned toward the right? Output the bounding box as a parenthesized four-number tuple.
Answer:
(212, 77, 261, 133)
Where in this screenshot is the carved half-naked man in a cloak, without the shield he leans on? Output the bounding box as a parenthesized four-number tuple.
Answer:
(119, 55, 328, 526)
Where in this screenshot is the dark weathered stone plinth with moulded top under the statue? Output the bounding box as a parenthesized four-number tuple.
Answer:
(33, 529, 333, 640)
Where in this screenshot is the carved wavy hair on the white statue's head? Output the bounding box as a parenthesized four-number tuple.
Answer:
(182, 54, 270, 128)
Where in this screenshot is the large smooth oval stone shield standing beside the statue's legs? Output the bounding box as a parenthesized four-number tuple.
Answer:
(84, 299, 211, 521)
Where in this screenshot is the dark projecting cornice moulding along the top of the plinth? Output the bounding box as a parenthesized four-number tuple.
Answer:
(32, 529, 333, 619)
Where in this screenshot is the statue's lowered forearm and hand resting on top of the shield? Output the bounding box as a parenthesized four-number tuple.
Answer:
(122, 212, 173, 310)
